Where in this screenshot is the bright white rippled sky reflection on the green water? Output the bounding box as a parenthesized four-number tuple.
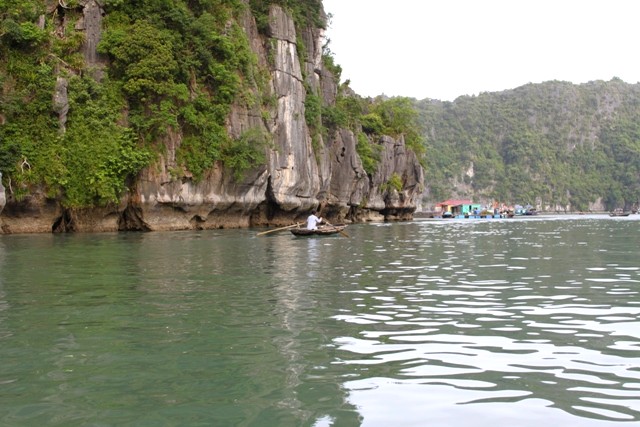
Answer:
(333, 221, 640, 426)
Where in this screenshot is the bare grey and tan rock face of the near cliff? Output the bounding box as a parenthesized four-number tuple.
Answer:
(0, 1, 423, 232)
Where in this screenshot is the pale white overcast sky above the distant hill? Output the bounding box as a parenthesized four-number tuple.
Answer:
(322, 0, 640, 101)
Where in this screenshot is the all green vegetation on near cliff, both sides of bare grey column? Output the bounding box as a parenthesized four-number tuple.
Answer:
(0, 0, 430, 212)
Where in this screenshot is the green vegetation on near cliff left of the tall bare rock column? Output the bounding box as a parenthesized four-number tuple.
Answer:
(0, 0, 278, 207)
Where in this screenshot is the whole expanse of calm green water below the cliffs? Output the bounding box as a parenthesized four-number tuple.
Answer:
(0, 215, 640, 427)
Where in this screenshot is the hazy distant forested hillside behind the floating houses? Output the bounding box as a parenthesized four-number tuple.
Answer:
(416, 79, 640, 211)
